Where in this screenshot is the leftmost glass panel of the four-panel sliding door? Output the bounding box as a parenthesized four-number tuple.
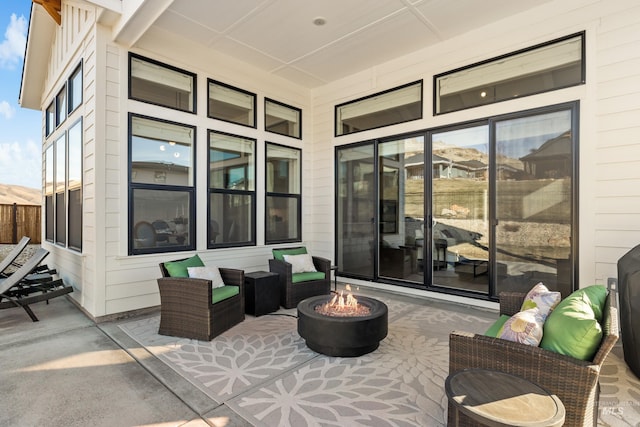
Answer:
(336, 144, 376, 279)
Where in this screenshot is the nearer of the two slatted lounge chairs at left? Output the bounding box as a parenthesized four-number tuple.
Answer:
(0, 248, 73, 322)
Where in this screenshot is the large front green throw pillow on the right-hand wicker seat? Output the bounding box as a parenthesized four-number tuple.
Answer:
(540, 286, 606, 360)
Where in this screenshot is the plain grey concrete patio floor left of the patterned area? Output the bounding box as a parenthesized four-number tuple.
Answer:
(0, 290, 636, 427)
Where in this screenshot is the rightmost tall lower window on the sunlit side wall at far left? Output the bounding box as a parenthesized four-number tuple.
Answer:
(67, 120, 82, 251)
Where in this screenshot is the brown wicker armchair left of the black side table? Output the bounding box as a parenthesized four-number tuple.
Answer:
(158, 260, 244, 341)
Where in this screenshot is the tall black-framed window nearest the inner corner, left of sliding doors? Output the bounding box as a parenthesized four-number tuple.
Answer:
(265, 143, 302, 244)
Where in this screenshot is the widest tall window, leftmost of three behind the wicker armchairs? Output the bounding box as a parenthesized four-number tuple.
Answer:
(129, 114, 195, 254)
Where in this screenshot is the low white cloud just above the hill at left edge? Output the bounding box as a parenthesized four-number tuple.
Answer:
(0, 140, 42, 188)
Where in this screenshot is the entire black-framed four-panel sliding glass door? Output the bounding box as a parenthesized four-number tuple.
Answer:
(336, 103, 578, 298)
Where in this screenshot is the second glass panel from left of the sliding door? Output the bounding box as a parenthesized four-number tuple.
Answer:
(378, 136, 424, 284)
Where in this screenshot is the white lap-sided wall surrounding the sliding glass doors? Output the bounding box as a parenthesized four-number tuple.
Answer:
(310, 0, 640, 287)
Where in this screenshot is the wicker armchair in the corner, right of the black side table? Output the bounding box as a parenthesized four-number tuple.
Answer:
(269, 248, 331, 308)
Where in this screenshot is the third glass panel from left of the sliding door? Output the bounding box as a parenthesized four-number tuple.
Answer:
(430, 125, 490, 293)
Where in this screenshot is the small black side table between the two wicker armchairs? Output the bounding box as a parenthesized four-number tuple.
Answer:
(244, 271, 280, 317)
